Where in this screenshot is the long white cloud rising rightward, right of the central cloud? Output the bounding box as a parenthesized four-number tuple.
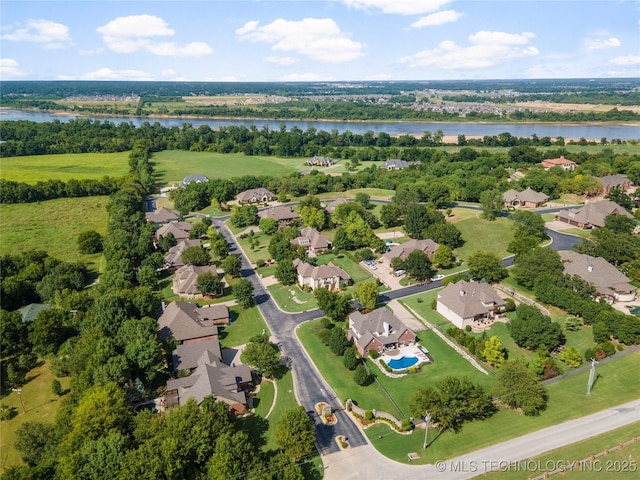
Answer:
(398, 31, 539, 70)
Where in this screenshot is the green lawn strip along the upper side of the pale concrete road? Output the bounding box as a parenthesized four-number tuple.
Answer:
(365, 352, 640, 464)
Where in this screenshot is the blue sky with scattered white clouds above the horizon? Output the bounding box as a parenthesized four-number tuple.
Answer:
(0, 0, 640, 81)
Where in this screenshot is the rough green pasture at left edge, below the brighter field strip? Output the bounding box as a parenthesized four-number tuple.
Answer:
(0, 196, 109, 270)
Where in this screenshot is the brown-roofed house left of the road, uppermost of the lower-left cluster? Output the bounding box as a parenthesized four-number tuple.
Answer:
(158, 302, 229, 344)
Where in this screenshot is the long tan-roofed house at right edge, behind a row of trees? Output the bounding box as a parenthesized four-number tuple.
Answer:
(560, 252, 636, 303)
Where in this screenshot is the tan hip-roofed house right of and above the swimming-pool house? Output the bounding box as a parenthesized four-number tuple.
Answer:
(438, 280, 504, 319)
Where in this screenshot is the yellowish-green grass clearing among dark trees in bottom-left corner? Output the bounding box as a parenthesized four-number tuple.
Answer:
(0, 362, 70, 472)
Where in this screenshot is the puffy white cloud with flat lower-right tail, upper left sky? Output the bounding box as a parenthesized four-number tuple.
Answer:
(96, 15, 213, 57)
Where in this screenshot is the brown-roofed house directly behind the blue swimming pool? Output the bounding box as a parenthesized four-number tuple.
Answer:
(347, 307, 416, 357)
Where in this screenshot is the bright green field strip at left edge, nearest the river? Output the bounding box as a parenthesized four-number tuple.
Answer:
(0, 152, 129, 183)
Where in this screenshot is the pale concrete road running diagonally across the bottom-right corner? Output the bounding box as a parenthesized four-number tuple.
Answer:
(323, 400, 640, 480)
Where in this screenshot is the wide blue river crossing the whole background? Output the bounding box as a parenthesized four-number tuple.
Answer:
(0, 109, 640, 141)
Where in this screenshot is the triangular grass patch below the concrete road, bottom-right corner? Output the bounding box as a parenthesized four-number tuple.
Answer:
(478, 423, 640, 480)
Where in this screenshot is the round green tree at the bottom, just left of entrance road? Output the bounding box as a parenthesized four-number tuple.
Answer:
(275, 406, 316, 458)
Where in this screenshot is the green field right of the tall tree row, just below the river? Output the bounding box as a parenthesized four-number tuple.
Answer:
(153, 150, 306, 184)
